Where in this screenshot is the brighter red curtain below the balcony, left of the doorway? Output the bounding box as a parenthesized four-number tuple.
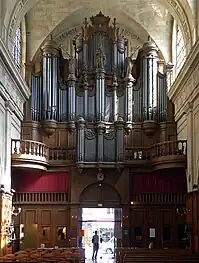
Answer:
(12, 171, 68, 192)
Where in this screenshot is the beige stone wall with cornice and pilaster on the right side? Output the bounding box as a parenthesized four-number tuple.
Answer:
(169, 40, 199, 191)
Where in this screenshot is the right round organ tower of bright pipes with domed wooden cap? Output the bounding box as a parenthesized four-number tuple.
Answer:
(140, 41, 158, 120)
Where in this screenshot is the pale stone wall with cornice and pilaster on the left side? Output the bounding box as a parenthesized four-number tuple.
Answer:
(0, 39, 30, 192)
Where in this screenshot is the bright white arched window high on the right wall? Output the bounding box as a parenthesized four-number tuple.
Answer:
(172, 21, 186, 76)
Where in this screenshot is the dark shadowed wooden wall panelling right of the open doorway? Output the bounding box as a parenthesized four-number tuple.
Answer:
(129, 204, 186, 248)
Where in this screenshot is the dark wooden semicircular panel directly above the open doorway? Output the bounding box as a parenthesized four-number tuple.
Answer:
(79, 182, 121, 207)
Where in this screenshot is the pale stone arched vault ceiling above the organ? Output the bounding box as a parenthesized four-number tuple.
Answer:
(1, 0, 194, 61)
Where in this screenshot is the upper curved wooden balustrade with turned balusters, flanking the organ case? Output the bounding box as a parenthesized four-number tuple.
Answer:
(12, 139, 187, 169)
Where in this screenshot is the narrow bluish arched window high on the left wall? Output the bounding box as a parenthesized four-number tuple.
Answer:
(13, 27, 21, 68)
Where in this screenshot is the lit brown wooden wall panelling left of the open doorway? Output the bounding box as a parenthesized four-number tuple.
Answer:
(16, 205, 70, 249)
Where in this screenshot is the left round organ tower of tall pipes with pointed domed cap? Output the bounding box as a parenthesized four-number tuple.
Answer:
(42, 38, 59, 120)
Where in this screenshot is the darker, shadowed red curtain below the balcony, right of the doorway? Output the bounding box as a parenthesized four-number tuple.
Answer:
(132, 169, 187, 194)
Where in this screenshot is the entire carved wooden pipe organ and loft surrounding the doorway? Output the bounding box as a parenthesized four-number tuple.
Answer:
(12, 12, 186, 252)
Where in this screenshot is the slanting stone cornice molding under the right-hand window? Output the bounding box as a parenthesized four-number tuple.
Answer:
(168, 39, 199, 103)
